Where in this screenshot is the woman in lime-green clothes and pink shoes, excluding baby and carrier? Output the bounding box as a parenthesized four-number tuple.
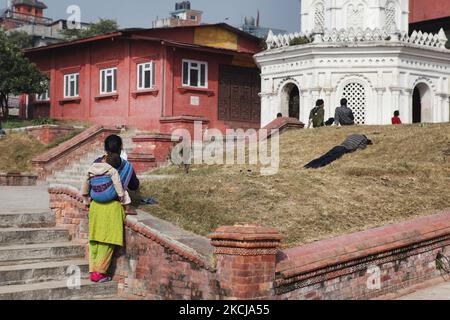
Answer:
(89, 135, 139, 282)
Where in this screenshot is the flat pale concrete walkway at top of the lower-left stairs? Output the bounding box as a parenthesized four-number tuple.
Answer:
(0, 183, 50, 214)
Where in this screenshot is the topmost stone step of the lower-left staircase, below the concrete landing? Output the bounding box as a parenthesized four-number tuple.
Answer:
(0, 212, 55, 228)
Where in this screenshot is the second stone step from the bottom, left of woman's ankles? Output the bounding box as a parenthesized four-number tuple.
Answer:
(0, 259, 89, 286)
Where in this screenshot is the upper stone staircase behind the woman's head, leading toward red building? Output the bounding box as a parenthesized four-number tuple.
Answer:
(46, 131, 135, 190)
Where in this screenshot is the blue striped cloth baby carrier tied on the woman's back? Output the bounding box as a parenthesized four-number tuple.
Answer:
(89, 159, 133, 203)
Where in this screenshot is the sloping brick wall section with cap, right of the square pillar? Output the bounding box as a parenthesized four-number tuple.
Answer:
(275, 213, 450, 299)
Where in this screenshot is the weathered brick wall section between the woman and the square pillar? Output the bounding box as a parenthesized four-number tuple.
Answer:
(114, 221, 219, 300)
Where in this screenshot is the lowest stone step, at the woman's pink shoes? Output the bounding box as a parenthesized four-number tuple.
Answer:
(0, 279, 117, 300)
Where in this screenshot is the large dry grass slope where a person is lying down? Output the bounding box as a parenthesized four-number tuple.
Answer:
(136, 124, 450, 246)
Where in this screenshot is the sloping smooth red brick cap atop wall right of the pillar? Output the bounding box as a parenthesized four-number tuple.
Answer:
(277, 212, 450, 279)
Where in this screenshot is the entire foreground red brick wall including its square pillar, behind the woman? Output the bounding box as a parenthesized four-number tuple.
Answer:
(45, 185, 450, 300)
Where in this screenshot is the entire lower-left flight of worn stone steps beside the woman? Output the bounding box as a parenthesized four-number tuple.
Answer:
(0, 212, 117, 300)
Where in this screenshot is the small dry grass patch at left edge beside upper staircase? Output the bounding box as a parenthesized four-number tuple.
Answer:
(0, 133, 47, 172)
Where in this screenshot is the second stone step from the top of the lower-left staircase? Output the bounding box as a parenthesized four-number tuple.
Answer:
(0, 228, 70, 247)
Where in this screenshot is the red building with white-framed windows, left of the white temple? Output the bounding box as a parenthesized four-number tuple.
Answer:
(26, 24, 261, 133)
